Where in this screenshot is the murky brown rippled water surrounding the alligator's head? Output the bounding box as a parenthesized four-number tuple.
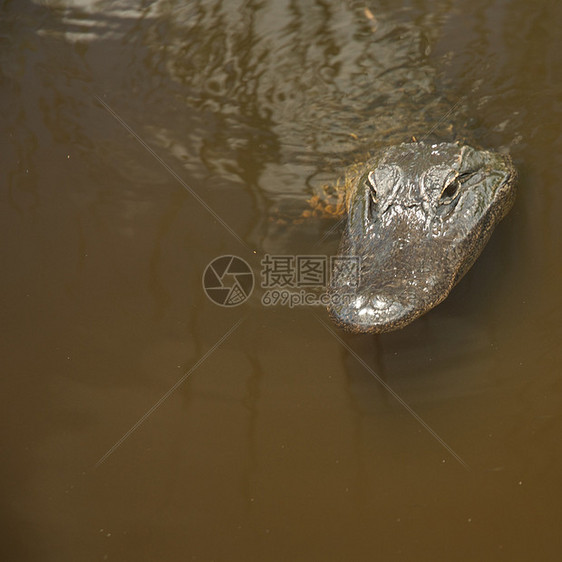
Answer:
(0, 0, 562, 561)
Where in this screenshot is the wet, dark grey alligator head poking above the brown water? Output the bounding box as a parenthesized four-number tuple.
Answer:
(328, 142, 517, 333)
